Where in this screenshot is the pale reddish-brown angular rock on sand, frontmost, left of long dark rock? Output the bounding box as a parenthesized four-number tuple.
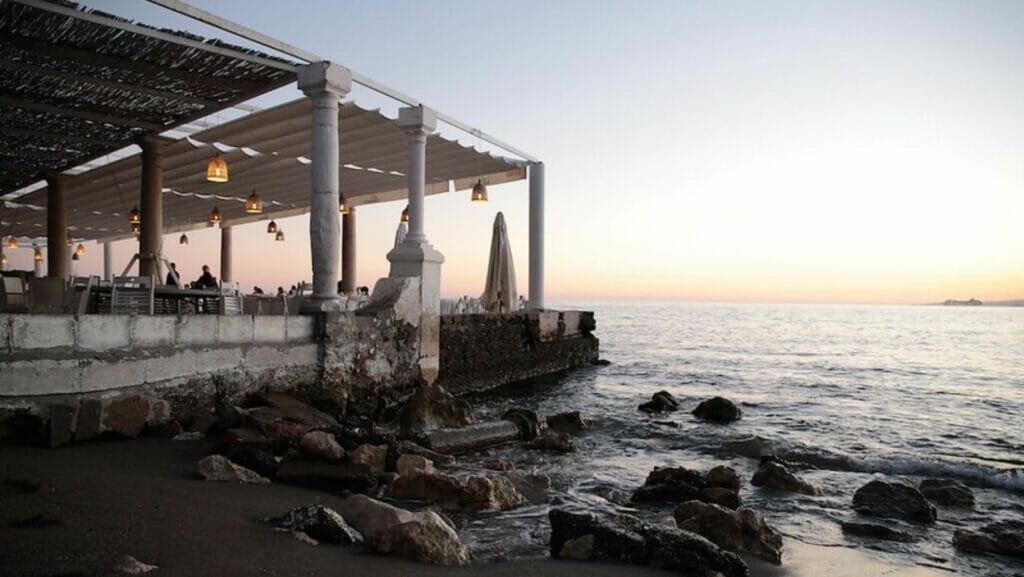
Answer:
(367, 511, 472, 566)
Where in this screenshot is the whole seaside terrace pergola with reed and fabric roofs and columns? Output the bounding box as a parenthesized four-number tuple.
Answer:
(0, 0, 544, 308)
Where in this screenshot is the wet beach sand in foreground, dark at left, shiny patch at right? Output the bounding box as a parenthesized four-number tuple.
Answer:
(0, 439, 946, 577)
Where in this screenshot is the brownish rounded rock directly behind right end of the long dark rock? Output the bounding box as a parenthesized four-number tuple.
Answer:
(674, 501, 782, 565)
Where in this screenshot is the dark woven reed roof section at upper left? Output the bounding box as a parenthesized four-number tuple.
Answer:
(0, 0, 296, 199)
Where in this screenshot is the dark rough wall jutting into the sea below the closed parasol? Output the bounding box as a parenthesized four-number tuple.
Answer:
(437, 311, 598, 395)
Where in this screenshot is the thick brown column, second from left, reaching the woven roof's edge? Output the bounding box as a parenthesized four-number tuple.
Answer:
(137, 133, 167, 281)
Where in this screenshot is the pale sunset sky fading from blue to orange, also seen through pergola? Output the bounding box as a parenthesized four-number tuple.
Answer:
(4, 0, 1024, 303)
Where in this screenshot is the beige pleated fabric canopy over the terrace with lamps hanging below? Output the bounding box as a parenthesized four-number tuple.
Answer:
(4, 98, 526, 240)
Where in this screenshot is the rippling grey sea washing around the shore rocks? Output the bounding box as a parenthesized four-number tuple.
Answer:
(448, 302, 1024, 575)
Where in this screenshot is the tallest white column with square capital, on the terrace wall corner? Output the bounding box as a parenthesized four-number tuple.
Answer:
(298, 61, 352, 312)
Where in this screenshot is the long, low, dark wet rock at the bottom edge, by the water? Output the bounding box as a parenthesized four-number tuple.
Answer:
(548, 509, 749, 577)
